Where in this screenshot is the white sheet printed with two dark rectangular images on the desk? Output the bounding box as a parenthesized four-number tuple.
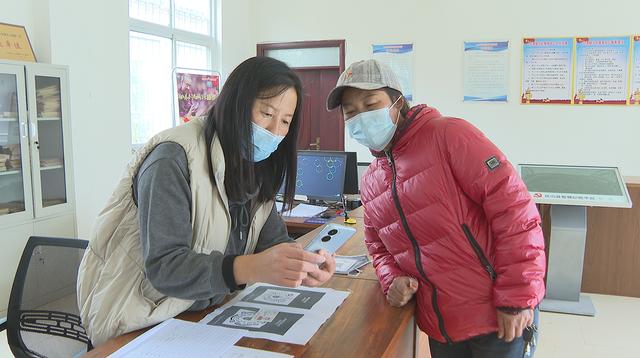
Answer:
(200, 283, 350, 345)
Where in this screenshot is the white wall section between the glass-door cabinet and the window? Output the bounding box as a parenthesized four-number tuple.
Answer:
(48, 0, 131, 239)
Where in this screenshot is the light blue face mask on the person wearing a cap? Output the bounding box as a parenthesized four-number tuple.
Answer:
(345, 98, 400, 152)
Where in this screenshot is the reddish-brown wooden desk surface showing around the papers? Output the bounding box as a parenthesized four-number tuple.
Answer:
(86, 206, 416, 357)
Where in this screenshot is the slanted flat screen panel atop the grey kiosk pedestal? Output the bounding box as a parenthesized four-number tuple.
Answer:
(519, 164, 631, 207)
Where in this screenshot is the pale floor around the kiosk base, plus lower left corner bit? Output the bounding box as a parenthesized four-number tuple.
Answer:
(0, 295, 640, 358)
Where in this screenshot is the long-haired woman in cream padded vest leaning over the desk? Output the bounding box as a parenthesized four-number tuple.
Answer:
(78, 57, 335, 344)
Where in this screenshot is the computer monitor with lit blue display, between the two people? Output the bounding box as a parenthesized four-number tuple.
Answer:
(280, 150, 347, 202)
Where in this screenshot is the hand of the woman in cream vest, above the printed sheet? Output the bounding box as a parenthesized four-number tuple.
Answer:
(233, 243, 328, 287)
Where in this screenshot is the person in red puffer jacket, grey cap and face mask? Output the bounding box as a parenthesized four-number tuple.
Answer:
(327, 60, 546, 358)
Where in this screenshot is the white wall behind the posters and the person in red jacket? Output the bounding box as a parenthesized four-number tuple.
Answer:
(248, 0, 640, 176)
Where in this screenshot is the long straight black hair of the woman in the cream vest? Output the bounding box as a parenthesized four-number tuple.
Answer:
(205, 57, 302, 210)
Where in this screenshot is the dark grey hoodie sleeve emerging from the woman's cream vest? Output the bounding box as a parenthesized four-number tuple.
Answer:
(134, 143, 230, 301)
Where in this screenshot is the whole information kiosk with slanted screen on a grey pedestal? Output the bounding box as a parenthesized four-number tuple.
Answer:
(519, 164, 632, 316)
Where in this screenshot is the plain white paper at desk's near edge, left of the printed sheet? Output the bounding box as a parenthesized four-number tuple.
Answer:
(109, 318, 246, 358)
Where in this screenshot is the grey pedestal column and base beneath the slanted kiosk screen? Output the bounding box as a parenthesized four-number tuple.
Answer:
(540, 205, 596, 316)
